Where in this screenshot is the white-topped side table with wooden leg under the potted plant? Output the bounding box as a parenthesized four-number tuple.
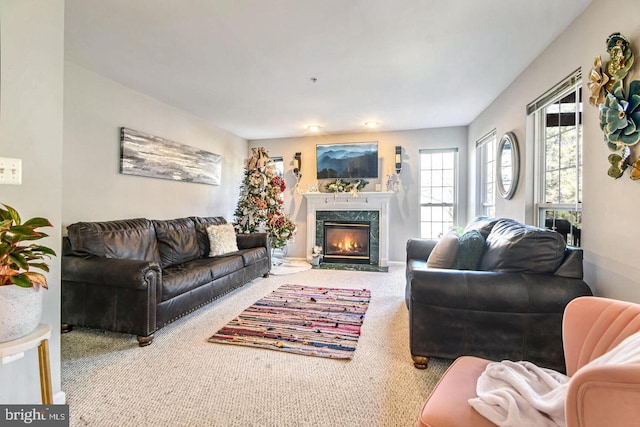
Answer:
(0, 323, 53, 405)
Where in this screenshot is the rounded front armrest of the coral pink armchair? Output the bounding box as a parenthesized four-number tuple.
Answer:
(565, 363, 640, 427)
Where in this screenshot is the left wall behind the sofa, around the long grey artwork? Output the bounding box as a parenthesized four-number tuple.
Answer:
(62, 62, 248, 226)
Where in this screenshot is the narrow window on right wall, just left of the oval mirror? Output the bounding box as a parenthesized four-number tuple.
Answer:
(476, 129, 496, 217)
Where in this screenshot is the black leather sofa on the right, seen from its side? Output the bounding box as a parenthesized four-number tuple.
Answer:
(406, 217, 592, 371)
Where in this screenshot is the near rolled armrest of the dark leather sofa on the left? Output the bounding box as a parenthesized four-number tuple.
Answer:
(61, 256, 162, 289)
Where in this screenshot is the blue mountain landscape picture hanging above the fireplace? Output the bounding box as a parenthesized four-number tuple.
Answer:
(316, 141, 378, 179)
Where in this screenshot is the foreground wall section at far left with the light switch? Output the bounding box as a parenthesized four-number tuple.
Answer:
(0, 0, 64, 404)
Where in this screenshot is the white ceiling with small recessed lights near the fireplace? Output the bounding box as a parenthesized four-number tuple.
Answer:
(65, 0, 591, 139)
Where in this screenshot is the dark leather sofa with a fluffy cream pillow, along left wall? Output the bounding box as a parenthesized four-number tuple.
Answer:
(61, 217, 271, 346)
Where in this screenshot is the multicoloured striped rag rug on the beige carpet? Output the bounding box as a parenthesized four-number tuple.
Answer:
(209, 285, 371, 359)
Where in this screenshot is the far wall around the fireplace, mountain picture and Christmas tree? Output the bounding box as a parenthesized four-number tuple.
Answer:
(249, 127, 468, 261)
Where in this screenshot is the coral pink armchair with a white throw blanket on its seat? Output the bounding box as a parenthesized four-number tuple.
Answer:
(418, 296, 640, 427)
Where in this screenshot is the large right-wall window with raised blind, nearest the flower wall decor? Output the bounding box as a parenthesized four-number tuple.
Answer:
(528, 70, 582, 246)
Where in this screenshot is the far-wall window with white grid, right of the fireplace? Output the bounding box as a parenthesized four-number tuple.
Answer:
(420, 149, 458, 239)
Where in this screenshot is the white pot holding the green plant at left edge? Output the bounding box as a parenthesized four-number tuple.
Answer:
(0, 285, 43, 343)
